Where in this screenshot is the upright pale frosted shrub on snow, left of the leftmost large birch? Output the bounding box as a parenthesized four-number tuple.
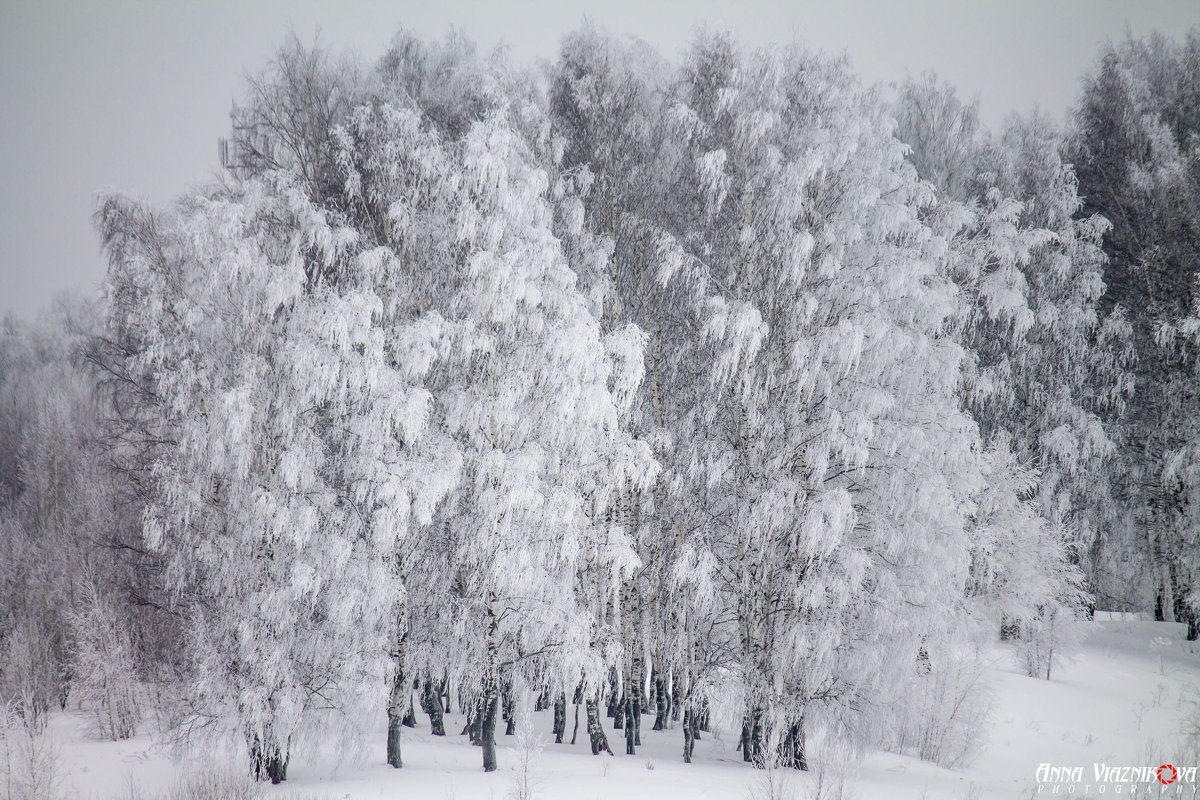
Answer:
(70, 587, 142, 740)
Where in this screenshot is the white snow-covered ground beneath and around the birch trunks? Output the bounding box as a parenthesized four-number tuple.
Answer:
(44, 621, 1200, 800)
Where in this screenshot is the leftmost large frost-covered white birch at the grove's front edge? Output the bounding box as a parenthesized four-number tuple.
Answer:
(94, 164, 454, 782)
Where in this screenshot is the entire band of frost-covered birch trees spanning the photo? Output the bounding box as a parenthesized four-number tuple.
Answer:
(0, 28, 1200, 782)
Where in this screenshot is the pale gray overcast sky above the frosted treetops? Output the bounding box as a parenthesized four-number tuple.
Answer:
(0, 0, 1200, 317)
